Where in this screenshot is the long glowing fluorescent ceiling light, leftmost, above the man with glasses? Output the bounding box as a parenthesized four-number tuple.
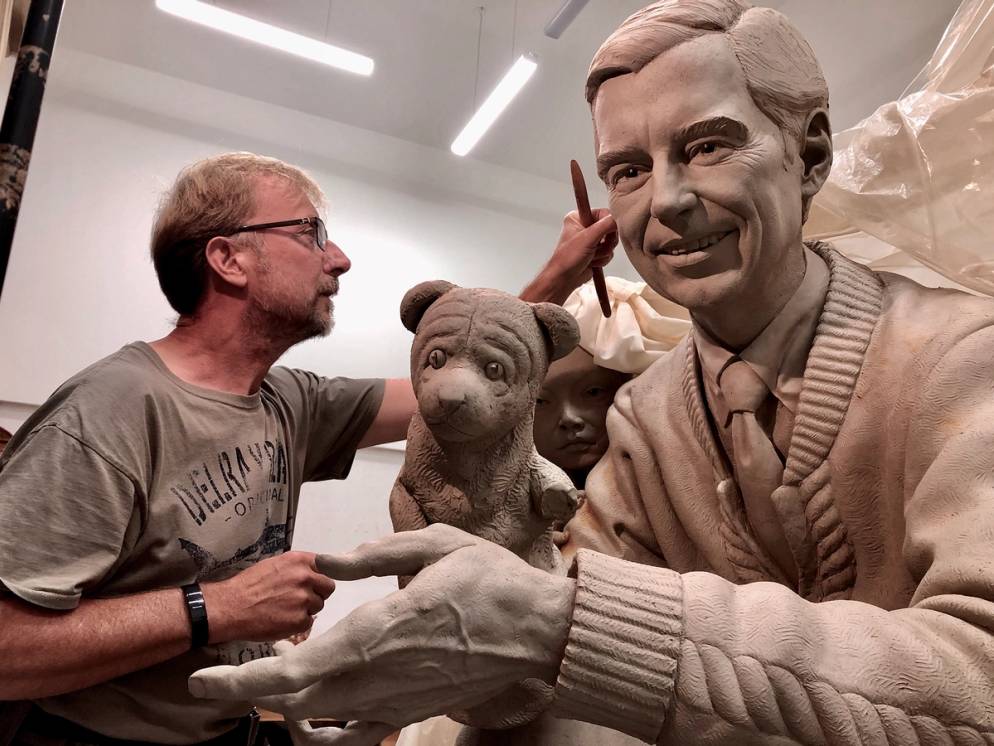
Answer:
(155, 0, 373, 75)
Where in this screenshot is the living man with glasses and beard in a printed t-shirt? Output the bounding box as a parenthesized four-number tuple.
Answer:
(0, 154, 414, 743)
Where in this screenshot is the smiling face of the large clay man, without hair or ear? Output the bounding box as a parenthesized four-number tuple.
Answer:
(594, 34, 803, 312)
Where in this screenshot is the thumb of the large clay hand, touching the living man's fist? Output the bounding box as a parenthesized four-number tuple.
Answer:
(317, 524, 478, 580)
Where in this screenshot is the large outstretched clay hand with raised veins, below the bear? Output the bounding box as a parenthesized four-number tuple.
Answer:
(190, 524, 575, 728)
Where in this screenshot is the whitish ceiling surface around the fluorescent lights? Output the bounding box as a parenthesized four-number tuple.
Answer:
(53, 0, 959, 181)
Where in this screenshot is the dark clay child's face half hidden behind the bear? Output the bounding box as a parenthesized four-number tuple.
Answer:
(535, 347, 630, 470)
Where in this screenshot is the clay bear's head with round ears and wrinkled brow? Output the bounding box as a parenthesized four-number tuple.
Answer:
(400, 281, 579, 447)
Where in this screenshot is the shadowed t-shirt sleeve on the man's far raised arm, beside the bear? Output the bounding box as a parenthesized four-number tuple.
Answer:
(272, 368, 385, 482)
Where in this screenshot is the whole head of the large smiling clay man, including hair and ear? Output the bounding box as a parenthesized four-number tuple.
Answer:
(587, 0, 832, 322)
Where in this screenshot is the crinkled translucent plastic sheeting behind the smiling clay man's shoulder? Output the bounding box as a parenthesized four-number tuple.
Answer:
(804, 0, 994, 295)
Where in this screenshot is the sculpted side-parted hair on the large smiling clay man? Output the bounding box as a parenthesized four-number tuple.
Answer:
(586, 0, 828, 158)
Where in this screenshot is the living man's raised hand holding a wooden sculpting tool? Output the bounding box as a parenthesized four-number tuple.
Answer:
(520, 209, 618, 304)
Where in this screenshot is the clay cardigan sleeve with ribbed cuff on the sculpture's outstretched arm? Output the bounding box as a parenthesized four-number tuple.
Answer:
(556, 331, 994, 746)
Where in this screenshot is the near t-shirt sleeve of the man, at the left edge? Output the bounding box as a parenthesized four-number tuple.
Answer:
(0, 425, 138, 609)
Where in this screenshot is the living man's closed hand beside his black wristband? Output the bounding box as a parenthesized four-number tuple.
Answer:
(203, 552, 335, 643)
